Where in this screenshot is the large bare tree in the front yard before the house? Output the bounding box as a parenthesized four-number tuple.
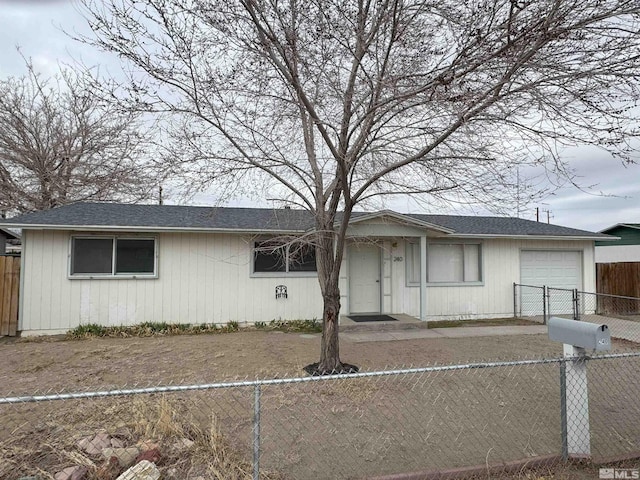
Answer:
(76, 0, 640, 372)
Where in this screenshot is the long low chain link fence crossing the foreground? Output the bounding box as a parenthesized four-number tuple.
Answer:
(0, 352, 640, 480)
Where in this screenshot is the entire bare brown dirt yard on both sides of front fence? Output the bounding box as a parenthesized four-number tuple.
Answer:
(0, 332, 640, 480)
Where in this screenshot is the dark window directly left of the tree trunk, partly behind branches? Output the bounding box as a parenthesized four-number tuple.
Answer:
(253, 240, 317, 274)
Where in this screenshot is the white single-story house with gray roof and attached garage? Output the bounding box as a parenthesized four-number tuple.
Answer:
(4, 203, 609, 334)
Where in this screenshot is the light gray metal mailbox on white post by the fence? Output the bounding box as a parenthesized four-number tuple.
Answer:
(548, 317, 611, 351)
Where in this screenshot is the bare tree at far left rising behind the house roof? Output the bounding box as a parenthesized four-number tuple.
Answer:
(0, 58, 155, 214)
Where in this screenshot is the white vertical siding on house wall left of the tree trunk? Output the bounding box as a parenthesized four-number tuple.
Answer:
(20, 230, 322, 333)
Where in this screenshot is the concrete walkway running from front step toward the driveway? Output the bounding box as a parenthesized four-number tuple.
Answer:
(340, 325, 547, 343)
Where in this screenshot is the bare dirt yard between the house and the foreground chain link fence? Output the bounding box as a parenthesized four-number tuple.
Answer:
(0, 332, 562, 395)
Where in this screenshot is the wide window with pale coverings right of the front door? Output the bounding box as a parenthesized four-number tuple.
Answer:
(406, 242, 482, 285)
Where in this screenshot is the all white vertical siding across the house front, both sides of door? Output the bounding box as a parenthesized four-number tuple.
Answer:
(20, 230, 595, 333)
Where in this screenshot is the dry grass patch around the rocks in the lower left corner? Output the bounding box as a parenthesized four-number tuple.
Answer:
(0, 396, 282, 480)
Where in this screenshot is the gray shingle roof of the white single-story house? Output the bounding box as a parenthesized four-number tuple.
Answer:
(0, 203, 611, 240)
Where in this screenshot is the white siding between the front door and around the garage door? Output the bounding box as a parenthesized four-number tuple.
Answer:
(388, 239, 596, 320)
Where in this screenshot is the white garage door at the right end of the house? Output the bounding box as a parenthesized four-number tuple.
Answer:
(520, 250, 582, 315)
